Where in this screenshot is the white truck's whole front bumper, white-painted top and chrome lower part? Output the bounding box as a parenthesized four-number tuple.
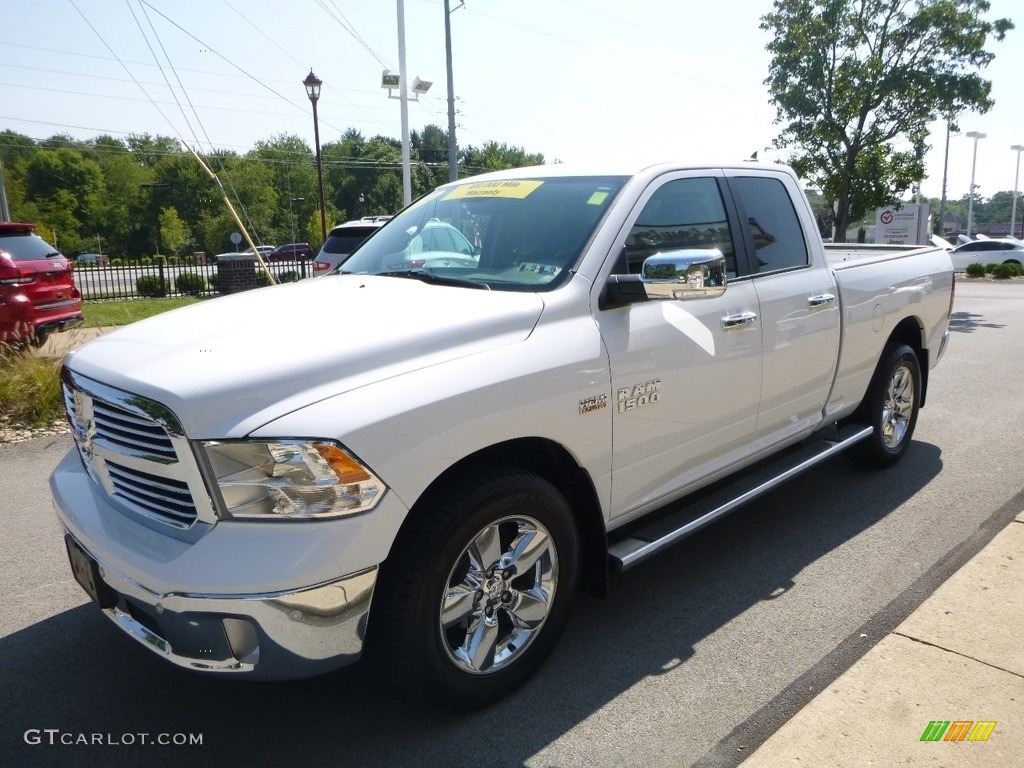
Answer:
(50, 449, 408, 679)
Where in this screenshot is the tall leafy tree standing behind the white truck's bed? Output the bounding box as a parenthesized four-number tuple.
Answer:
(761, 0, 1014, 242)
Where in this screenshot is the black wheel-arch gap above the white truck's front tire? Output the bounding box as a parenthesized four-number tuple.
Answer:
(398, 437, 608, 597)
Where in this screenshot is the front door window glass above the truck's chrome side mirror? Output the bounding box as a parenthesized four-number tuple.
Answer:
(626, 178, 736, 278)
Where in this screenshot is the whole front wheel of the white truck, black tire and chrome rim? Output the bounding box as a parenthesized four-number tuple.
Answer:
(368, 468, 580, 710)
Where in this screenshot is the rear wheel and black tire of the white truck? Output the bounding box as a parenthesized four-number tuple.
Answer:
(850, 343, 922, 468)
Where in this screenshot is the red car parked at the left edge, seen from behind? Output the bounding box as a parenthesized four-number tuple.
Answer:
(0, 221, 82, 343)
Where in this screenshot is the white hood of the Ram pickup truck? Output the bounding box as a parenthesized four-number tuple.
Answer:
(66, 274, 544, 438)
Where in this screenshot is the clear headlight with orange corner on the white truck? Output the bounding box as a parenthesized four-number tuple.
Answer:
(202, 440, 386, 519)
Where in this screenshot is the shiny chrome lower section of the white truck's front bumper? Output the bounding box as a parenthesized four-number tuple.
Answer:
(69, 534, 377, 679)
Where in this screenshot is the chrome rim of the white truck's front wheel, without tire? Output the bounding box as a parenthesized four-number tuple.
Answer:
(439, 516, 558, 675)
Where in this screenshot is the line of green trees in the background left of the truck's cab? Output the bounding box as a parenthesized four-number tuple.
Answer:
(0, 125, 544, 263)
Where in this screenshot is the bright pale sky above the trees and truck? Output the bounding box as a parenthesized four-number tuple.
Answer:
(0, 0, 1024, 207)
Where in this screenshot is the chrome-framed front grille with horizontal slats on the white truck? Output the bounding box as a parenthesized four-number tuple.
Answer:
(61, 368, 205, 536)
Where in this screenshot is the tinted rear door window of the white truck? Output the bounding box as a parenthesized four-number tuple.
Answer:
(730, 176, 810, 273)
